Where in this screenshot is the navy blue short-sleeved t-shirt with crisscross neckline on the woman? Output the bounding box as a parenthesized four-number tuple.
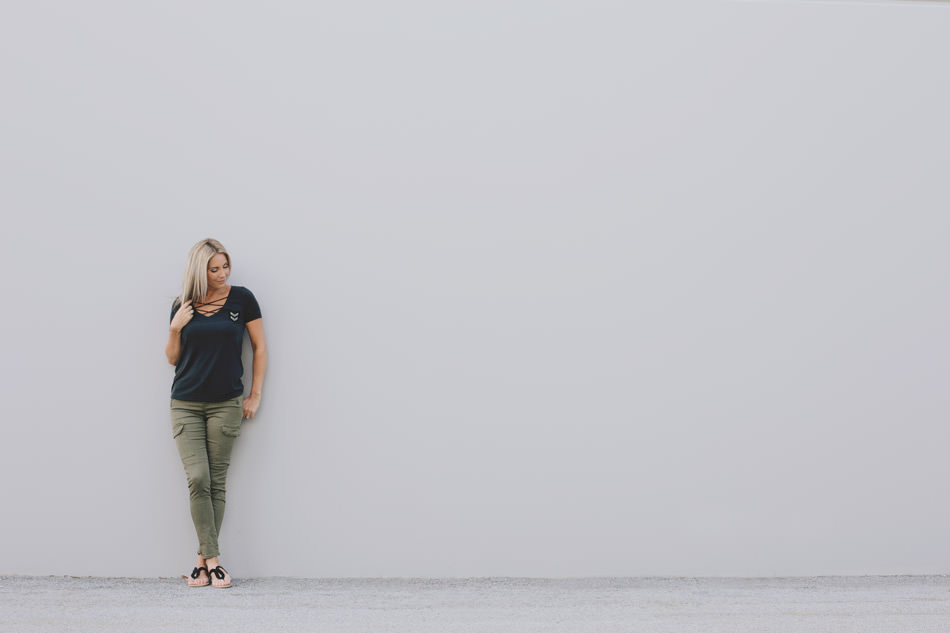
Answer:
(169, 286, 261, 402)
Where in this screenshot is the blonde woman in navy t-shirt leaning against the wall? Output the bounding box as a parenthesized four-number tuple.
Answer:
(165, 238, 267, 587)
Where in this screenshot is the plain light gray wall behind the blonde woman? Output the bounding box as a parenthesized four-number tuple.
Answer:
(0, 0, 950, 576)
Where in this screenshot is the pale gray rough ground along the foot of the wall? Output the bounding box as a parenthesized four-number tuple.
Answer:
(0, 576, 950, 633)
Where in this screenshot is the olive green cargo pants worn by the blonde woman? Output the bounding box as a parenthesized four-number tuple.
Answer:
(171, 398, 243, 558)
